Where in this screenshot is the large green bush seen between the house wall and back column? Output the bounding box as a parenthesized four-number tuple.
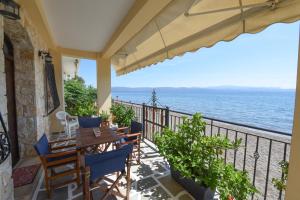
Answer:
(64, 76, 97, 116)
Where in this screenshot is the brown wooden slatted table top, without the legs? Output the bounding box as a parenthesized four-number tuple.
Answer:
(76, 128, 120, 148)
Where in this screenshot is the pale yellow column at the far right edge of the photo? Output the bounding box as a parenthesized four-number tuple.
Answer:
(285, 27, 300, 200)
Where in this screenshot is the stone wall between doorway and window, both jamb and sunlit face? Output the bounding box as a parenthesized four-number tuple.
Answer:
(4, 14, 49, 158)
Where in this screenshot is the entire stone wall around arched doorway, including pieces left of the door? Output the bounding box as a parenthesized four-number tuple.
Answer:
(0, 7, 54, 200)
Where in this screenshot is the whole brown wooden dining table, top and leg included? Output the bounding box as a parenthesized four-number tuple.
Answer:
(76, 128, 120, 199)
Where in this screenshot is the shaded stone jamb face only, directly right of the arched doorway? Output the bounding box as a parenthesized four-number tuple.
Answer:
(4, 19, 37, 158)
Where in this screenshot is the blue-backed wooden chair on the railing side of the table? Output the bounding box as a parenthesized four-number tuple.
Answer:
(117, 121, 143, 164)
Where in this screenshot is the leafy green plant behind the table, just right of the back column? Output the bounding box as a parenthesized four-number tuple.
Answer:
(110, 104, 135, 127)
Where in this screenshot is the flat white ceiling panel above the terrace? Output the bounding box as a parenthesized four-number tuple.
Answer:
(42, 0, 134, 52)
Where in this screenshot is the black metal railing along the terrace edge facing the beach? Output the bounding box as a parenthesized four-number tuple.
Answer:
(114, 100, 291, 200)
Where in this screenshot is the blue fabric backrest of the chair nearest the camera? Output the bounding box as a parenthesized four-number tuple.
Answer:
(85, 144, 133, 180)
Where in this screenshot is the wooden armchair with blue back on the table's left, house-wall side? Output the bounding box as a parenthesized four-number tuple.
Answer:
(34, 134, 80, 197)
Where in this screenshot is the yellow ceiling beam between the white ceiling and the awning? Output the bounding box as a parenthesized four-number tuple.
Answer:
(103, 0, 172, 58)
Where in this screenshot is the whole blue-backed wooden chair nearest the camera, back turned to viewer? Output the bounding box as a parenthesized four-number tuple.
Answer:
(84, 144, 133, 199)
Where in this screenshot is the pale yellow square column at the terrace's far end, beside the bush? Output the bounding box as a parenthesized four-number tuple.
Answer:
(97, 58, 111, 113)
